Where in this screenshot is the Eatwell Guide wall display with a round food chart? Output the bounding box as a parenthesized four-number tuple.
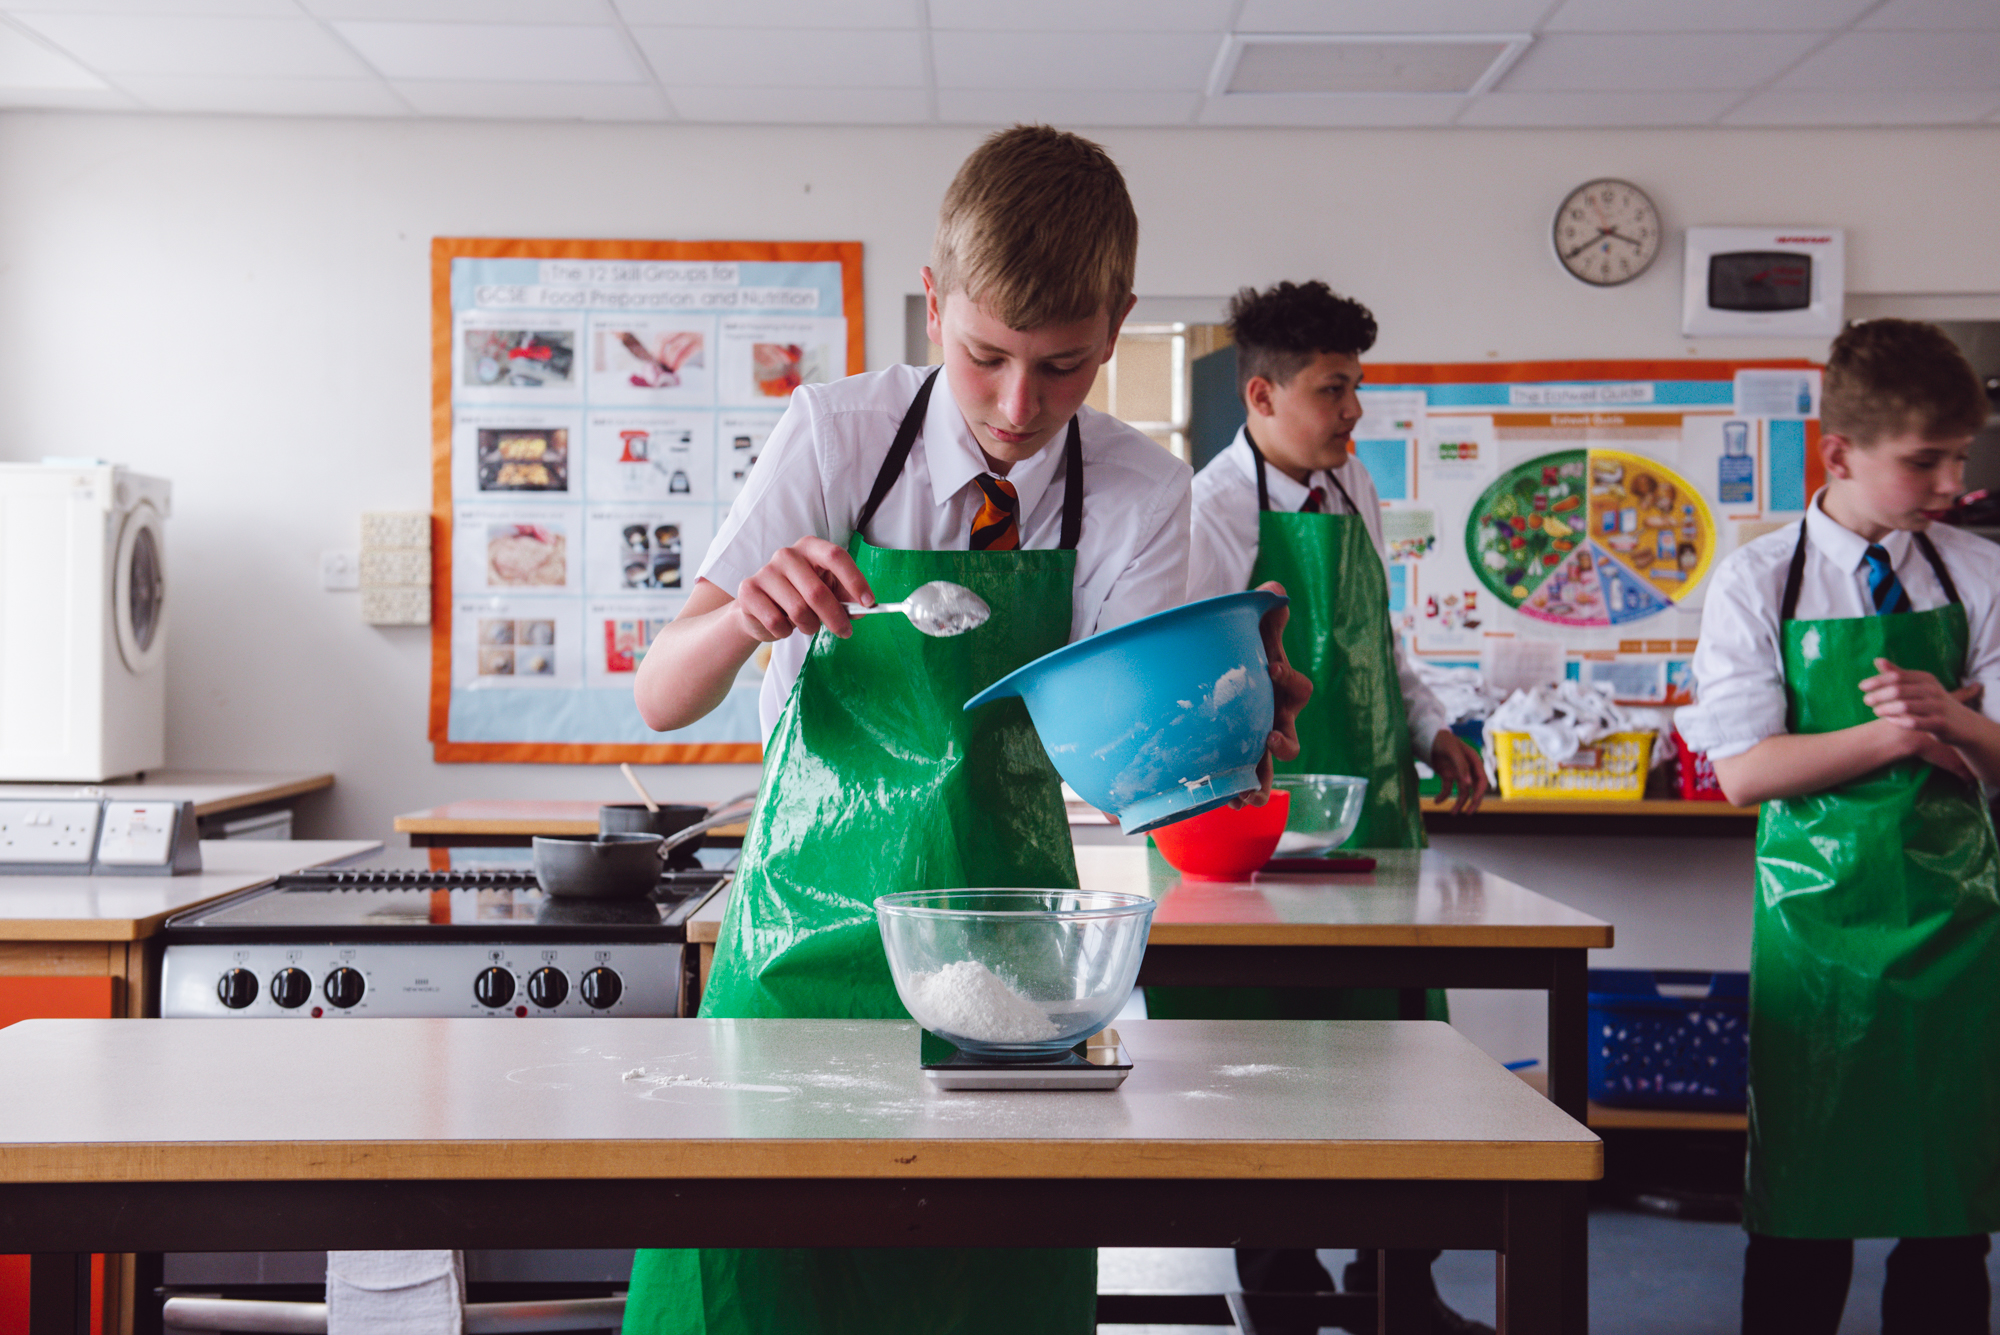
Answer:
(1354, 353, 1820, 703)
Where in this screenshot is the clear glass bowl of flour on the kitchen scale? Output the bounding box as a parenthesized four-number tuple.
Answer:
(876, 889, 1154, 1061)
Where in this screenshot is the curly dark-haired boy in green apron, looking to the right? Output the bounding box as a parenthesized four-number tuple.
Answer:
(1146, 282, 1486, 1335)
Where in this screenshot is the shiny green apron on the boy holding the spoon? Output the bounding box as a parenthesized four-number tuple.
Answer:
(624, 376, 1098, 1335)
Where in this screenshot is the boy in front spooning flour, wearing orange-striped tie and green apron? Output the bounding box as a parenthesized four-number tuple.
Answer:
(624, 126, 1310, 1335)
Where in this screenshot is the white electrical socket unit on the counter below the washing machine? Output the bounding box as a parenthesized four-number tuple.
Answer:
(0, 797, 202, 875)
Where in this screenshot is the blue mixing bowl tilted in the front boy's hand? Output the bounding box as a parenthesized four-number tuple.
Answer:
(966, 590, 1286, 833)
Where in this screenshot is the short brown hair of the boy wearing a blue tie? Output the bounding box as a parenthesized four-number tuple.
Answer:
(1820, 320, 1990, 446)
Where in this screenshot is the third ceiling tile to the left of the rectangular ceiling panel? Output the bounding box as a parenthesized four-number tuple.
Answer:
(334, 22, 646, 84)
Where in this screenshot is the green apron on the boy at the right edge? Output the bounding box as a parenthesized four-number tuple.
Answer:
(1744, 526, 2000, 1239)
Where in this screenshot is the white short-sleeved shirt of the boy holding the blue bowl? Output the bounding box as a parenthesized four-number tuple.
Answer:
(698, 366, 1190, 737)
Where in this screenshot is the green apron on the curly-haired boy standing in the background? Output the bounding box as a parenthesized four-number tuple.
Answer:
(1146, 432, 1446, 1019)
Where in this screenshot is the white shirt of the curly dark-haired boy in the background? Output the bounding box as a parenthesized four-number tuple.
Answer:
(1188, 428, 1452, 763)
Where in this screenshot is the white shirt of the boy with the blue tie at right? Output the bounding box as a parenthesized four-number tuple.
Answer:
(1674, 492, 2000, 759)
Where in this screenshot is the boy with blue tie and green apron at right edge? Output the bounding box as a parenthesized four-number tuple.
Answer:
(1678, 320, 2000, 1335)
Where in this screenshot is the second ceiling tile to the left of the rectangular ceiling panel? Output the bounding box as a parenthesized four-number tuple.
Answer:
(632, 28, 930, 88)
